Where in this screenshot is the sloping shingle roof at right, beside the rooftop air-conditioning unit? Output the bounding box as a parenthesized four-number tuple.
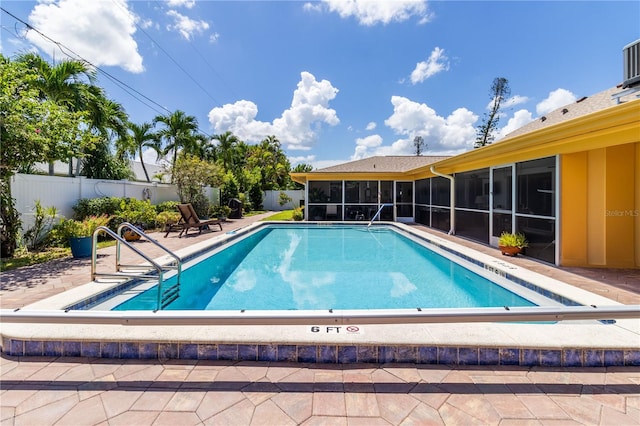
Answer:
(496, 86, 640, 143)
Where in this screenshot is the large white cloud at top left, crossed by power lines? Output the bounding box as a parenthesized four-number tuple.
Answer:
(27, 0, 144, 73)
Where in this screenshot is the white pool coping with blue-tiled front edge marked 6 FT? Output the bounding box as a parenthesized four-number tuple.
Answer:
(1, 221, 640, 367)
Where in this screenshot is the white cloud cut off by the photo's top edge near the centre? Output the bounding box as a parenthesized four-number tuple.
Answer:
(314, 0, 431, 26)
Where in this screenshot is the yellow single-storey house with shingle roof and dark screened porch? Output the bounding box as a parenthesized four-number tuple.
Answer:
(291, 87, 640, 268)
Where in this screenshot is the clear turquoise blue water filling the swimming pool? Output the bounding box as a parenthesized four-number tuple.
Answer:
(114, 225, 534, 310)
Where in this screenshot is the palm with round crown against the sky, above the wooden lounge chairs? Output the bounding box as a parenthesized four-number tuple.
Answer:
(153, 110, 198, 183)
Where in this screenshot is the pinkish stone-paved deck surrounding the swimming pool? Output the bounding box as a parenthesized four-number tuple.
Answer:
(0, 214, 640, 425)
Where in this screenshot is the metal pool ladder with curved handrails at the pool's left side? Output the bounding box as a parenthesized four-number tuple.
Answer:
(91, 222, 182, 310)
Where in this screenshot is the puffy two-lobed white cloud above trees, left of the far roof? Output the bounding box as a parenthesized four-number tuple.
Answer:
(209, 71, 340, 150)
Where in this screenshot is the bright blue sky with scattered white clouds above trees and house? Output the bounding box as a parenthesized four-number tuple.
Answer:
(0, 0, 640, 168)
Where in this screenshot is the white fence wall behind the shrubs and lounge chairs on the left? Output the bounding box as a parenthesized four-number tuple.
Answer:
(11, 174, 304, 231)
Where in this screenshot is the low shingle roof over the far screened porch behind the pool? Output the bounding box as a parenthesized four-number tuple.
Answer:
(311, 155, 449, 173)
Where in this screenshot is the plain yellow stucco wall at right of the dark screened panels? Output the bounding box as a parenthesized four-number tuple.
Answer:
(560, 143, 640, 268)
